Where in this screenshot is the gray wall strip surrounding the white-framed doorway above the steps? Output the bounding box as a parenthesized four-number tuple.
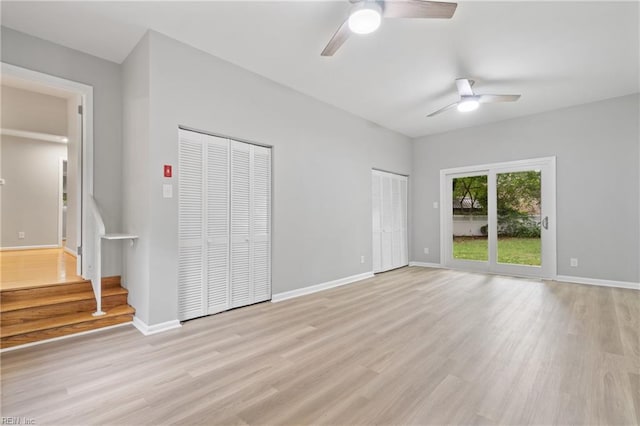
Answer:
(0, 27, 122, 275)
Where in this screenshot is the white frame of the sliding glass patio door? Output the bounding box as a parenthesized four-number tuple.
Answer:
(440, 156, 557, 279)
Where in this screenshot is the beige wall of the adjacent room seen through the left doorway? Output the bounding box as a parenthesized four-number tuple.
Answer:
(0, 86, 67, 247)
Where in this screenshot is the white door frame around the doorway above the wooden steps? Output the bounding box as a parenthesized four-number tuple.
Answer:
(0, 62, 93, 276)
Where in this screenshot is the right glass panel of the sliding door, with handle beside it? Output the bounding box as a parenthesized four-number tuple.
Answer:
(496, 170, 542, 266)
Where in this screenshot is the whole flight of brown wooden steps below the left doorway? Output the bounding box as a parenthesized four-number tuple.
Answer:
(0, 277, 135, 349)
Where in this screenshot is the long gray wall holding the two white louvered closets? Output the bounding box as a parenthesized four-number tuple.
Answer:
(125, 32, 411, 324)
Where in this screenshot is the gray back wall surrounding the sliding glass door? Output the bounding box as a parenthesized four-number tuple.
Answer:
(412, 95, 640, 282)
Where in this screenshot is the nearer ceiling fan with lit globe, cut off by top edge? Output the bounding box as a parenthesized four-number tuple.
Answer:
(322, 0, 458, 56)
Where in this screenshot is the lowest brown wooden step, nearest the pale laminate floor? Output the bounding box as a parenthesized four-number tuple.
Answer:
(0, 308, 133, 349)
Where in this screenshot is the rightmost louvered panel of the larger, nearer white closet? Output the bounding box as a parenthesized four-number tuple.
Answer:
(250, 146, 271, 302)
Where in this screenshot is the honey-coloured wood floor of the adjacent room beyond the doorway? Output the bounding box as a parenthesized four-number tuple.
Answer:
(0, 248, 82, 290)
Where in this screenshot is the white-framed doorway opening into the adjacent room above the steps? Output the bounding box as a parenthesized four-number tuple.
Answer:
(0, 63, 93, 285)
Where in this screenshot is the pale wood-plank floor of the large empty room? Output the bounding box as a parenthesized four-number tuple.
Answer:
(1, 268, 640, 425)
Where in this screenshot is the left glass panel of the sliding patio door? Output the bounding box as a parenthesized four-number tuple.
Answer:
(451, 175, 489, 262)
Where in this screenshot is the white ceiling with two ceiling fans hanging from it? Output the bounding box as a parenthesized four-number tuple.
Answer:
(2, 0, 640, 137)
